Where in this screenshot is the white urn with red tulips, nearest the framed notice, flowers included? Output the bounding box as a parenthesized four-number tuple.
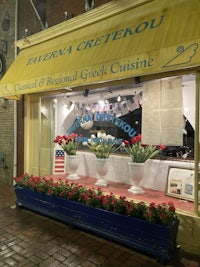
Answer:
(124, 134, 165, 194)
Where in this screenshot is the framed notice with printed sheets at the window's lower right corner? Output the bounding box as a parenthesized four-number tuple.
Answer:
(166, 167, 194, 201)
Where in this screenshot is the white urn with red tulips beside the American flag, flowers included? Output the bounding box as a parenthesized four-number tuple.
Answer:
(53, 133, 81, 180)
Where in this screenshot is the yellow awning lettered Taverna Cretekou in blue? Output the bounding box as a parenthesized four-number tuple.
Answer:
(0, 0, 200, 97)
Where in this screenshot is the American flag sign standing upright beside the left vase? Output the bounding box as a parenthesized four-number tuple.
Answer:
(53, 149, 66, 174)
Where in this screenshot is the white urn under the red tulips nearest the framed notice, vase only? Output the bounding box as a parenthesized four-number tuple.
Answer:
(128, 161, 145, 194)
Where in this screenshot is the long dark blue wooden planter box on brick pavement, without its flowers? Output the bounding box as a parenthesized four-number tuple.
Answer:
(14, 187, 179, 260)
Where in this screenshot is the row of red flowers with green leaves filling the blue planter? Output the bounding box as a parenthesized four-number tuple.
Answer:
(14, 175, 177, 225)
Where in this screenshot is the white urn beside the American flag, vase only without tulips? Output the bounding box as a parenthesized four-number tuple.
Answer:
(66, 155, 80, 180)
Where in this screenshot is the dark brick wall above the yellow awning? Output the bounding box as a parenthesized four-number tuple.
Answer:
(18, 0, 111, 39)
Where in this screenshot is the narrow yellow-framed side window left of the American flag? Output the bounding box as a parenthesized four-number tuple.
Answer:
(25, 95, 56, 175)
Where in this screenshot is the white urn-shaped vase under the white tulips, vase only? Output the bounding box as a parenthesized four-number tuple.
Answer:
(95, 158, 109, 186)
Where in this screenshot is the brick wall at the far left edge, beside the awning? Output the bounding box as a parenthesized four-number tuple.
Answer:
(0, 0, 15, 184)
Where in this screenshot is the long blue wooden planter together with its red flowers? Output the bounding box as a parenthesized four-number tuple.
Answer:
(14, 174, 179, 260)
